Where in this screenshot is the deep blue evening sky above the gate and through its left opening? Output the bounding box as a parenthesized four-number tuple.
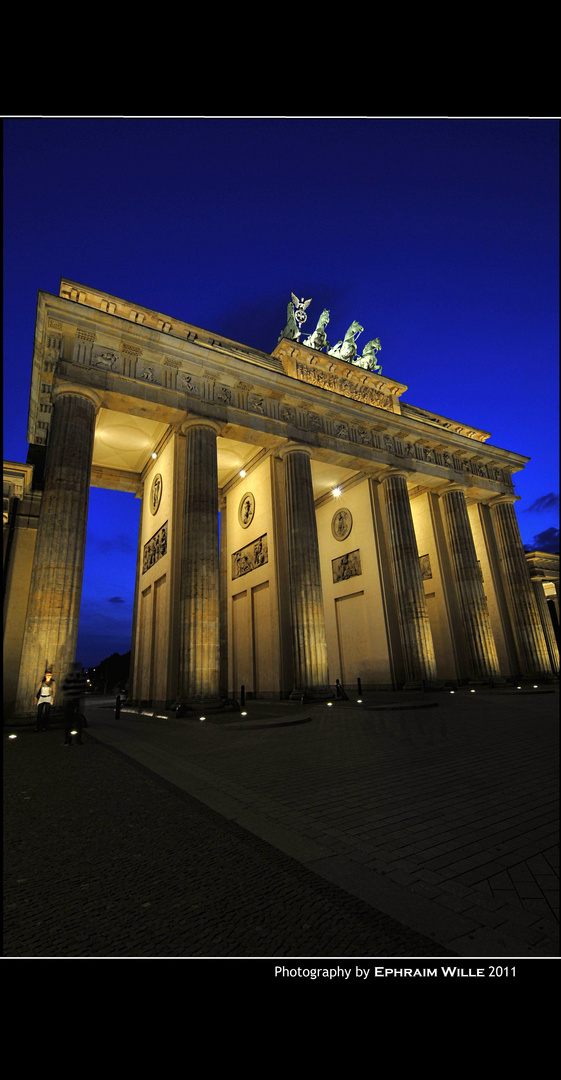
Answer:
(3, 117, 559, 664)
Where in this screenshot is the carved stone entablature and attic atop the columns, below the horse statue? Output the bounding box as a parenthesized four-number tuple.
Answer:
(28, 281, 529, 497)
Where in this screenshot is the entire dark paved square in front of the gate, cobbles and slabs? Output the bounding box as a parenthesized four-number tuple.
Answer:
(4, 688, 559, 958)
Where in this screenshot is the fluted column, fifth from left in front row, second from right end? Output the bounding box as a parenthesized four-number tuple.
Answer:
(441, 485, 500, 681)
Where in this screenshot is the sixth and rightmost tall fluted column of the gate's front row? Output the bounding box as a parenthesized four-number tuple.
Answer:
(490, 496, 552, 678)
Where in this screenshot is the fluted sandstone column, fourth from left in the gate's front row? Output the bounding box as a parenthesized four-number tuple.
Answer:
(379, 470, 437, 688)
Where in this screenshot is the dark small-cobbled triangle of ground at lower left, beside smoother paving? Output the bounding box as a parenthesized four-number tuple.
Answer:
(3, 729, 446, 958)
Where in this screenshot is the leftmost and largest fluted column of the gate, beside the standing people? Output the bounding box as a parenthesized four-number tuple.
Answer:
(15, 384, 99, 713)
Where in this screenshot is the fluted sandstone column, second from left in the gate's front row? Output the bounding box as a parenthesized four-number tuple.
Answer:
(178, 419, 221, 703)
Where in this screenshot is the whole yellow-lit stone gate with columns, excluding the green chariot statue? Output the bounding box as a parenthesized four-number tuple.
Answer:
(4, 280, 559, 713)
